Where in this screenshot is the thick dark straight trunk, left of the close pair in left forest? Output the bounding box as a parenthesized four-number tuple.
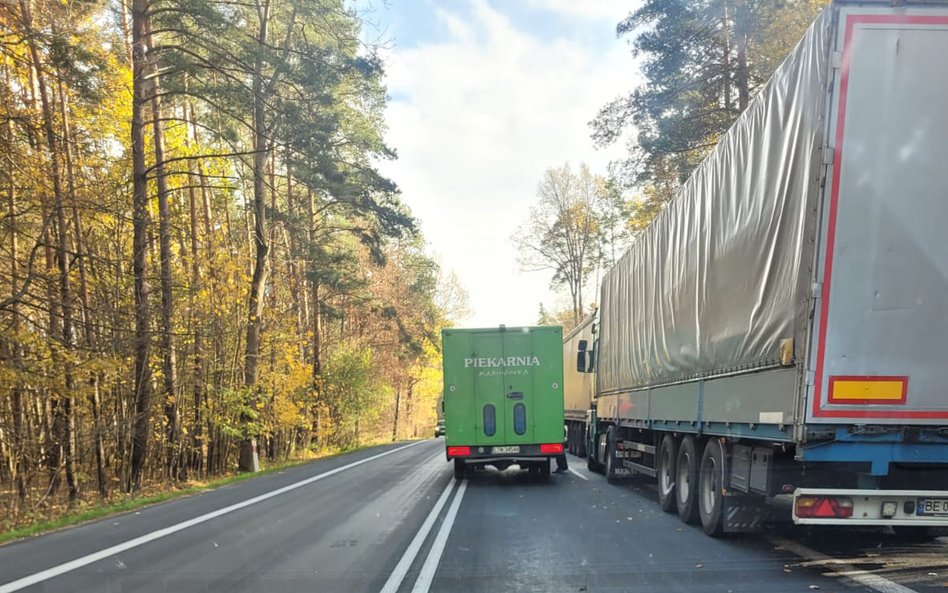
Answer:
(125, 0, 151, 492)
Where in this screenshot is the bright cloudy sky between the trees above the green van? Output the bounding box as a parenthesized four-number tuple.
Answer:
(366, 0, 640, 327)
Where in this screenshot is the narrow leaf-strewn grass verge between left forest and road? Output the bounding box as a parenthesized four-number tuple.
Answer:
(0, 443, 396, 545)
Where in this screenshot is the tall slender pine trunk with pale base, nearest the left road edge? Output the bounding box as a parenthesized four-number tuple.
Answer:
(239, 0, 270, 471)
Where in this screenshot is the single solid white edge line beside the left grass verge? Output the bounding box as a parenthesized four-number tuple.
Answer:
(0, 441, 425, 593)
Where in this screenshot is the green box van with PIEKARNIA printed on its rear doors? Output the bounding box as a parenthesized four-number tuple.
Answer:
(441, 326, 563, 479)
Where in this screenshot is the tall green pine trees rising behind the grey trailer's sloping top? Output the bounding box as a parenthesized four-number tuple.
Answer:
(591, 0, 827, 229)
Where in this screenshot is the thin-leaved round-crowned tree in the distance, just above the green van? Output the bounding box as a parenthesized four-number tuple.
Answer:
(512, 164, 606, 323)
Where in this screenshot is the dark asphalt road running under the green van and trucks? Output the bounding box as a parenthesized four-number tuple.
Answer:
(0, 440, 948, 593)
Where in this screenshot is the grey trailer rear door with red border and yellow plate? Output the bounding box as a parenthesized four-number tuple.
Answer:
(807, 6, 948, 424)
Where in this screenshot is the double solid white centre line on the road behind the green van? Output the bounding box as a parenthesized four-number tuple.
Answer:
(380, 480, 467, 593)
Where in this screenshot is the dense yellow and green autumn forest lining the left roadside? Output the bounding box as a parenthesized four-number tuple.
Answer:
(0, 0, 466, 529)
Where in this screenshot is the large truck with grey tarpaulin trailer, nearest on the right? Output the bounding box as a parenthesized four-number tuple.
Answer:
(570, 0, 948, 536)
